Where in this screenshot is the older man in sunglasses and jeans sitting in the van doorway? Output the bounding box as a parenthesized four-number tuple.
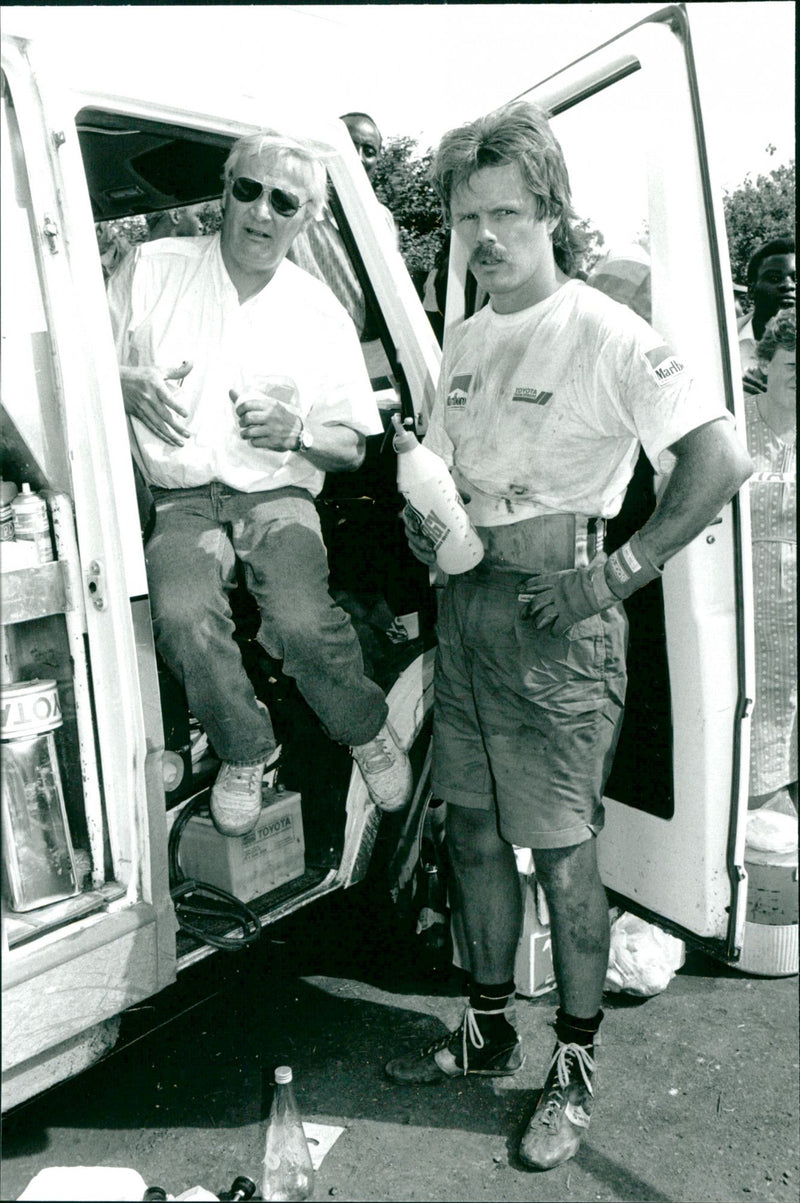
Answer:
(108, 131, 411, 836)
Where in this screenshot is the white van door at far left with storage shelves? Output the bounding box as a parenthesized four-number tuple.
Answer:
(0, 41, 176, 1106)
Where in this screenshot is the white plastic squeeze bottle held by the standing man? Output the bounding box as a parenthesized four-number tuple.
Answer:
(392, 414, 484, 576)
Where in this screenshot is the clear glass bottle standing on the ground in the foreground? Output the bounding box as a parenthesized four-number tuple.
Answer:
(261, 1065, 314, 1201)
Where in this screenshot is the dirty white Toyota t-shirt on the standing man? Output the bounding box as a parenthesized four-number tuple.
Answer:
(425, 280, 727, 526)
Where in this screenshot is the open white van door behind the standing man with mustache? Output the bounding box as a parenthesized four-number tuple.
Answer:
(445, 6, 754, 959)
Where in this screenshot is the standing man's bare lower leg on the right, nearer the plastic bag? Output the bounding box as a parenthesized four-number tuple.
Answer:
(533, 840, 610, 1019)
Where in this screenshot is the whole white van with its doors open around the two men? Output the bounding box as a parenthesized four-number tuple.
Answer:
(0, 7, 753, 1108)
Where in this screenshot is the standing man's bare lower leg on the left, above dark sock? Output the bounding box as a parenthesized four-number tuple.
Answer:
(446, 805, 522, 983)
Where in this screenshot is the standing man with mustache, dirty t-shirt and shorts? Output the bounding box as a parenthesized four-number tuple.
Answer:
(386, 102, 751, 1169)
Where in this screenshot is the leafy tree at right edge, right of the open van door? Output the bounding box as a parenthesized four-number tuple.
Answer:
(722, 157, 795, 284)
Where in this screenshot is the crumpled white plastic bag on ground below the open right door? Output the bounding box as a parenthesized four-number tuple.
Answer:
(605, 911, 686, 998)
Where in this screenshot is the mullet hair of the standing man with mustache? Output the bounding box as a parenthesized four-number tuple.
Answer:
(431, 100, 586, 275)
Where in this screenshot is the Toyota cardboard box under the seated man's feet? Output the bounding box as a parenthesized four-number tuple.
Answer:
(178, 787, 306, 902)
